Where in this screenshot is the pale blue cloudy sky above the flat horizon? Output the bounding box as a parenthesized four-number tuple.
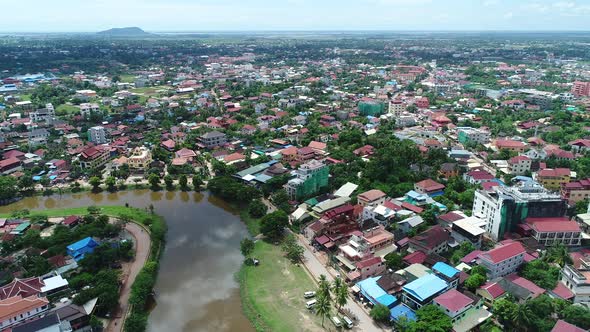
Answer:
(0, 0, 590, 32)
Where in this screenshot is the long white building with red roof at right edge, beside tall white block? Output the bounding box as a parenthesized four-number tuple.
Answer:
(526, 217, 582, 246)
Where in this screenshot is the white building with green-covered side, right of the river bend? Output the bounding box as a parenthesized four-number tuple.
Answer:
(285, 159, 330, 199)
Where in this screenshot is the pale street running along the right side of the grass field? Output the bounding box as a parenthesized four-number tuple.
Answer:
(297, 236, 385, 332)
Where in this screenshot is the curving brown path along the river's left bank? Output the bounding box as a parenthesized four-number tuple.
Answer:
(105, 219, 151, 332)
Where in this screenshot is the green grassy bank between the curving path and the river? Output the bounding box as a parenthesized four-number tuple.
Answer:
(0, 206, 166, 332)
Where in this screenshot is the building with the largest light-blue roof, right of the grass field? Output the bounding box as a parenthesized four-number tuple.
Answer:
(402, 274, 448, 309)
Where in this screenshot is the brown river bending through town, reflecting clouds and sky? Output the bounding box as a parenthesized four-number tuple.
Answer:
(0, 190, 254, 332)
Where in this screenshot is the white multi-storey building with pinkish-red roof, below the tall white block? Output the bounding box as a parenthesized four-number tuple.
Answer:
(477, 242, 526, 279)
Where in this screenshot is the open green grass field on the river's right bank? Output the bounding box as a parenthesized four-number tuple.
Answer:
(238, 241, 326, 331)
